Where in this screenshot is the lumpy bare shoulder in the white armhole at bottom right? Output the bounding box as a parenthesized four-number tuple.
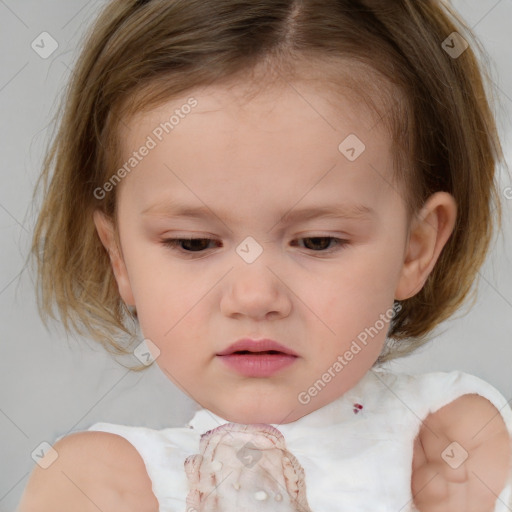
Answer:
(411, 395, 512, 512)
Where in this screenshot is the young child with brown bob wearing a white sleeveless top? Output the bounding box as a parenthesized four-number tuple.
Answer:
(20, 0, 512, 512)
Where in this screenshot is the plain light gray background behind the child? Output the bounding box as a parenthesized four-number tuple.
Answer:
(0, 0, 512, 512)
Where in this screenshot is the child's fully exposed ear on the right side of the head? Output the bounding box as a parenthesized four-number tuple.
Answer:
(395, 192, 457, 300)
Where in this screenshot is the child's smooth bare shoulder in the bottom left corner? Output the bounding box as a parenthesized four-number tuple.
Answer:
(17, 431, 158, 512)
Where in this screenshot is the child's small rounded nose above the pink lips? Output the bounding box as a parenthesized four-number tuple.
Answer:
(220, 254, 293, 320)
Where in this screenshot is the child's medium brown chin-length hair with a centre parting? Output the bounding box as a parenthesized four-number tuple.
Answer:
(32, 0, 502, 370)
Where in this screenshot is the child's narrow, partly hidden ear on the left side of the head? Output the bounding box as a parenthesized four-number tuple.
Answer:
(93, 210, 135, 306)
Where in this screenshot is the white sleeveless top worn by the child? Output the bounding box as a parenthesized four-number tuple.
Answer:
(79, 368, 512, 512)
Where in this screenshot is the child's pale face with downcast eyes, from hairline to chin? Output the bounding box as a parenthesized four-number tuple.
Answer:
(96, 80, 414, 423)
